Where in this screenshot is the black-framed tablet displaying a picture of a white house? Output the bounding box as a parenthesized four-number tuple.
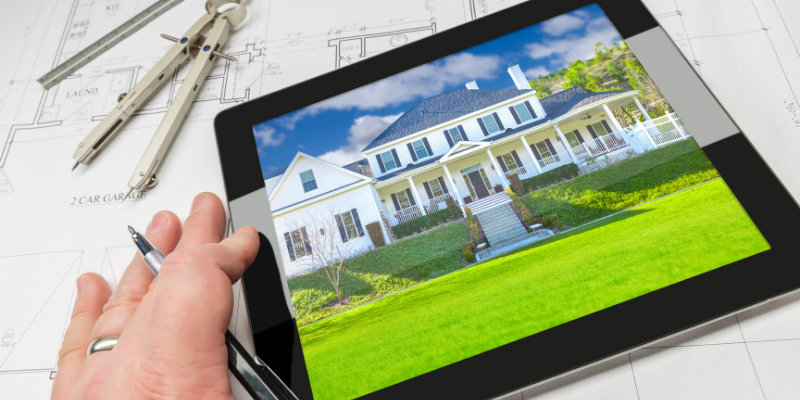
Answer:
(215, 0, 800, 400)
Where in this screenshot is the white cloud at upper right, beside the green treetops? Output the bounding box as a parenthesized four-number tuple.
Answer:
(525, 17, 620, 68)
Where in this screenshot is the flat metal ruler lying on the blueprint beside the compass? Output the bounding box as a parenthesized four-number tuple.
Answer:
(36, 0, 183, 89)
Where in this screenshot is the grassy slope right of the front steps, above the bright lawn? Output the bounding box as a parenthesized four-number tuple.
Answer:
(524, 140, 719, 227)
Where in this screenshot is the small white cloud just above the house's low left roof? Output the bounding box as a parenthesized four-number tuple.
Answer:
(319, 113, 403, 165)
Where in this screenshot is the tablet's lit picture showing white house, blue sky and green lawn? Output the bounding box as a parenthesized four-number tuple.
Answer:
(253, 6, 769, 399)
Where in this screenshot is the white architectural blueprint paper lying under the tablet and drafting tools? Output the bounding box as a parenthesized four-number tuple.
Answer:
(0, 0, 800, 399)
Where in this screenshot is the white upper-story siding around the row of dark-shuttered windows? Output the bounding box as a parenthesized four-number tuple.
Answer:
(365, 94, 545, 177)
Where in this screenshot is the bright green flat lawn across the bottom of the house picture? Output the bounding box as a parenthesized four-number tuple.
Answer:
(300, 180, 769, 400)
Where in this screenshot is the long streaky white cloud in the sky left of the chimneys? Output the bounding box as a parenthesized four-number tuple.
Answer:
(279, 53, 503, 129)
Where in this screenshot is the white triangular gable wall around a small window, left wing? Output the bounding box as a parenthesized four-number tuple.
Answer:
(270, 156, 361, 211)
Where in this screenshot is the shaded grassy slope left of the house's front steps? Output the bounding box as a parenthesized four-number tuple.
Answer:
(289, 222, 467, 326)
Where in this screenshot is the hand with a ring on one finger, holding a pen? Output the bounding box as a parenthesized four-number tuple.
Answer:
(51, 193, 259, 400)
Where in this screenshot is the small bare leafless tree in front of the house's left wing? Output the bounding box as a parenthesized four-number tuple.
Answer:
(282, 200, 358, 304)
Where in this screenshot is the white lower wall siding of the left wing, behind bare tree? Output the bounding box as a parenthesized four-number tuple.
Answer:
(273, 184, 380, 276)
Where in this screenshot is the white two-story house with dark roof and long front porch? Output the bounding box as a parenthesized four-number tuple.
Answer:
(265, 65, 687, 275)
